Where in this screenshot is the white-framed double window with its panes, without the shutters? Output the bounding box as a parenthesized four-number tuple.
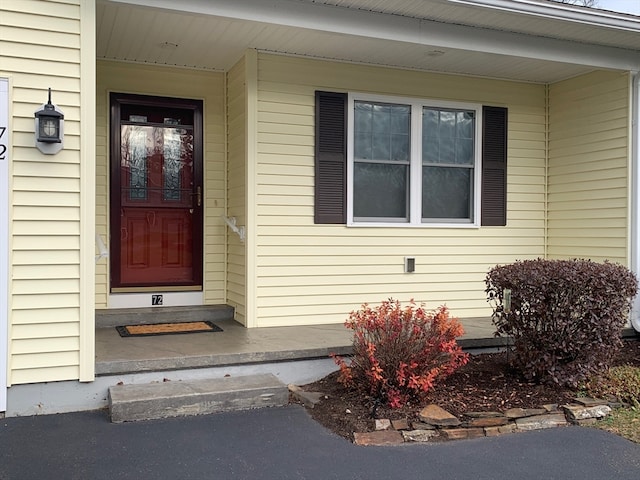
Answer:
(347, 94, 482, 225)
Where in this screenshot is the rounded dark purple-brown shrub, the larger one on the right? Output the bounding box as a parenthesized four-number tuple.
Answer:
(485, 259, 637, 387)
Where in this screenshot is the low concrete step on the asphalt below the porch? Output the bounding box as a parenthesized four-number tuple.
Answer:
(109, 373, 289, 423)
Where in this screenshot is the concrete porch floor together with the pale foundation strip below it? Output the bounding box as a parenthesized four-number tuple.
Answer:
(6, 316, 637, 417)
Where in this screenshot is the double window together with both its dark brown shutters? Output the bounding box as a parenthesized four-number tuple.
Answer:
(314, 91, 508, 227)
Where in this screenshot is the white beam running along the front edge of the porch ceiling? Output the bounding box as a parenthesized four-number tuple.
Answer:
(110, 0, 640, 71)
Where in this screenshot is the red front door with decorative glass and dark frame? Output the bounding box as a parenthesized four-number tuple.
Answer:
(111, 94, 202, 292)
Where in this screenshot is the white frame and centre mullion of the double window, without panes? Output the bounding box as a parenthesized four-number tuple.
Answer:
(347, 93, 482, 228)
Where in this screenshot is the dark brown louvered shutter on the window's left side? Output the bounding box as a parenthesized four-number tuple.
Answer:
(314, 92, 347, 223)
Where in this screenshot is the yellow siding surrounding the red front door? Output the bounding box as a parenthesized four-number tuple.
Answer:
(96, 61, 226, 308)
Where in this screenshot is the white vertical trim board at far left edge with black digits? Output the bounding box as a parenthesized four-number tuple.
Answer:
(0, 78, 10, 412)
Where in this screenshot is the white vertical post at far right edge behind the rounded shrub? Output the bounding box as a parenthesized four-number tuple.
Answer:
(631, 72, 640, 332)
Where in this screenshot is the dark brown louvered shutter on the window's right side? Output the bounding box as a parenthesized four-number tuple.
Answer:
(481, 107, 507, 227)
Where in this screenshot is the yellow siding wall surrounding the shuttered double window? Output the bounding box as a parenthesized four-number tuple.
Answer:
(250, 54, 546, 326)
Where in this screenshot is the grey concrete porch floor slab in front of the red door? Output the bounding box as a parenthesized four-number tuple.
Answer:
(96, 318, 504, 375)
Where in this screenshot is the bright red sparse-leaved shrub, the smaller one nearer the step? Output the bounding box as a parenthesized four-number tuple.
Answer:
(335, 299, 468, 408)
